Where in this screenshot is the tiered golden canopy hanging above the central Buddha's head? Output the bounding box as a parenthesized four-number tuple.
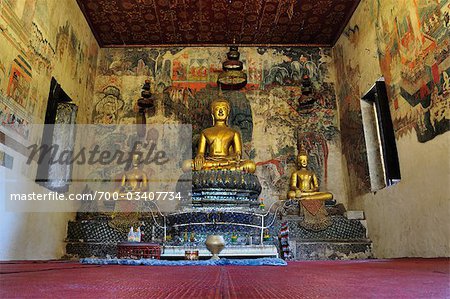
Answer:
(217, 46, 247, 90)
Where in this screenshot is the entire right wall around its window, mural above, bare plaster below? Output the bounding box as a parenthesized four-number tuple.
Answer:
(333, 0, 450, 258)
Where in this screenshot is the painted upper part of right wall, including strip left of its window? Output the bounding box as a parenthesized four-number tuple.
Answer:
(333, 0, 450, 202)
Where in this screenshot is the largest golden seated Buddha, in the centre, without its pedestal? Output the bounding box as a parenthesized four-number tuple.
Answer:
(183, 99, 256, 173)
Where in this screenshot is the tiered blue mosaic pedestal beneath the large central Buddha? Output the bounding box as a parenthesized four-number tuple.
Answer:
(169, 169, 278, 258)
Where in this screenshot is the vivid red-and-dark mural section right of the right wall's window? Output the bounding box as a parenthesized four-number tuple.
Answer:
(376, 0, 450, 142)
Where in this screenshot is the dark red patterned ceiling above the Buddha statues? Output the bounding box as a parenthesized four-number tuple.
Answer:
(77, 0, 360, 47)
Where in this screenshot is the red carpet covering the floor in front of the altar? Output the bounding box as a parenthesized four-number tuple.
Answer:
(0, 259, 450, 298)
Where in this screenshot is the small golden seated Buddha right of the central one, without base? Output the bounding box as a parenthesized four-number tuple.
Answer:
(287, 150, 333, 200)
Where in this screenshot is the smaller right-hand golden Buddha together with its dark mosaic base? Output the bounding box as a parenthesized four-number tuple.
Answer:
(276, 148, 372, 260)
